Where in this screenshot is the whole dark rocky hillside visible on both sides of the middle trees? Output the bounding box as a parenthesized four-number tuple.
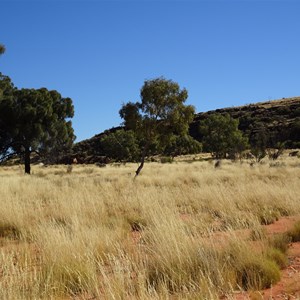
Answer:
(68, 97, 300, 163)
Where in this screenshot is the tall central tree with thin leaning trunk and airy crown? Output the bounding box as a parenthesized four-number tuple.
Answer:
(120, 78, 194, 176)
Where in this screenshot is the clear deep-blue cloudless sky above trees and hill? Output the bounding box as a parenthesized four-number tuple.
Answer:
(0, 0, 300, 141)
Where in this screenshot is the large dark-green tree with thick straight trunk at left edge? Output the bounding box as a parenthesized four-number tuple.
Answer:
(0, 73, 75, 174)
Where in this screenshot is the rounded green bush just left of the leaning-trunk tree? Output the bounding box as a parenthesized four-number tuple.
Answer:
(100, 129, 140, 161)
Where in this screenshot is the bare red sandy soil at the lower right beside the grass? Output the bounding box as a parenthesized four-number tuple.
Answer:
(231, 217, 300, 300)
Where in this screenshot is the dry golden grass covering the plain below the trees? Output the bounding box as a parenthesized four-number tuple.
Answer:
(0, 156, 300, 299)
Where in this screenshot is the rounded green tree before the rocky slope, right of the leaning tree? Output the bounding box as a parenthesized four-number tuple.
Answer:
(199, 114, 248, 159)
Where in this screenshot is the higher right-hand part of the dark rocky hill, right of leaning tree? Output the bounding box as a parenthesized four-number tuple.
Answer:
(190, 97, 300, 148)
